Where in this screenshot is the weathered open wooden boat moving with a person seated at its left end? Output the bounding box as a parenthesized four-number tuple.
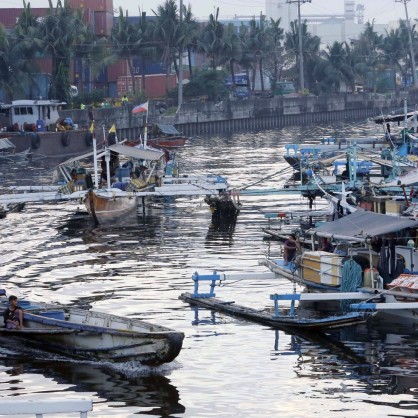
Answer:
(1, 302, 184, 366)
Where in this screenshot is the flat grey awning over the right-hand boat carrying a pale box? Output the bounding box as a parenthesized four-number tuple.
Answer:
(310, 211, 418, 241)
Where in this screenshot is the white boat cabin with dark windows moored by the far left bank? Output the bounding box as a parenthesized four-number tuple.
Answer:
(0, 100, 66, 132)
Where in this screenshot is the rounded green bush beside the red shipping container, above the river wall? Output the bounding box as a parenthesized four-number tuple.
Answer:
(183, 70, 228, 101)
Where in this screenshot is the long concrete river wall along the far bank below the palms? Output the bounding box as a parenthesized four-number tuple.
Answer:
(62, 93, 416, 139)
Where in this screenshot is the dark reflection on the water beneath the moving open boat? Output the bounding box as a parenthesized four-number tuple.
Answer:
(0, 343, 185, 416)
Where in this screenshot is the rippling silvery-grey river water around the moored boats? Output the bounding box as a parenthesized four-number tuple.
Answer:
(0, 119, 418, 418)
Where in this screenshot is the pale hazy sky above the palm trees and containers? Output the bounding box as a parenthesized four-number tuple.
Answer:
(0, 0, 418, 23)
